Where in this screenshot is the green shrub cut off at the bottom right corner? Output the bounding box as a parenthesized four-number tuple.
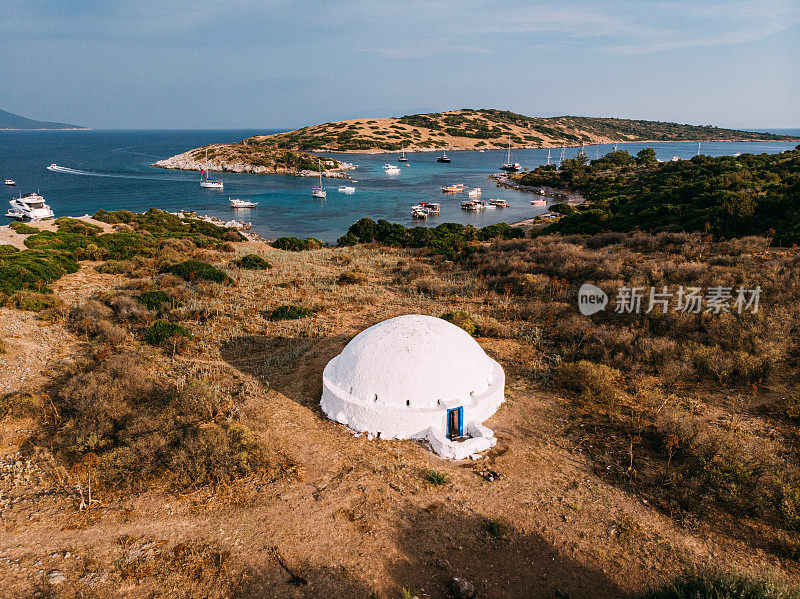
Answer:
(639, 571, 800, 599)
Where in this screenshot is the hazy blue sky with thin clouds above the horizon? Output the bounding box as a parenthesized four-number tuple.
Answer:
(0, 0, 800, 129)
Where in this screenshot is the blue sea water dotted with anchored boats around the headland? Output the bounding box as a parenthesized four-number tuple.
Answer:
(0, 129, 800, 243)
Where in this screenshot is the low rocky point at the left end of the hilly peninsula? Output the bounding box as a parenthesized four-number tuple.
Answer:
(152, 140, 355, 178)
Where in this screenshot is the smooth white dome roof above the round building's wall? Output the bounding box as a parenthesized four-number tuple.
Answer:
(324, 314, 498, 409)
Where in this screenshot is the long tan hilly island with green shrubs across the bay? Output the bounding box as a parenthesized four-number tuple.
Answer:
(153, 108, 796, 176)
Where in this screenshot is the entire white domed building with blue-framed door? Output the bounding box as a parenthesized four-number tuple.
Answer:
(321, 314, 505, 459)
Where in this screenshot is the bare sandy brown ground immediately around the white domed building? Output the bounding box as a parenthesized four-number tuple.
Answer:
(0, 242, 800, 599)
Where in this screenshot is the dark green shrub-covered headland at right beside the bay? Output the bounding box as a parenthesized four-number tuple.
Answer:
(514, 146, 800, 245)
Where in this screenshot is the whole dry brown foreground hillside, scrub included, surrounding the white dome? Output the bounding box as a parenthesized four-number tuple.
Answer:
(0, 226, 800, 599)
